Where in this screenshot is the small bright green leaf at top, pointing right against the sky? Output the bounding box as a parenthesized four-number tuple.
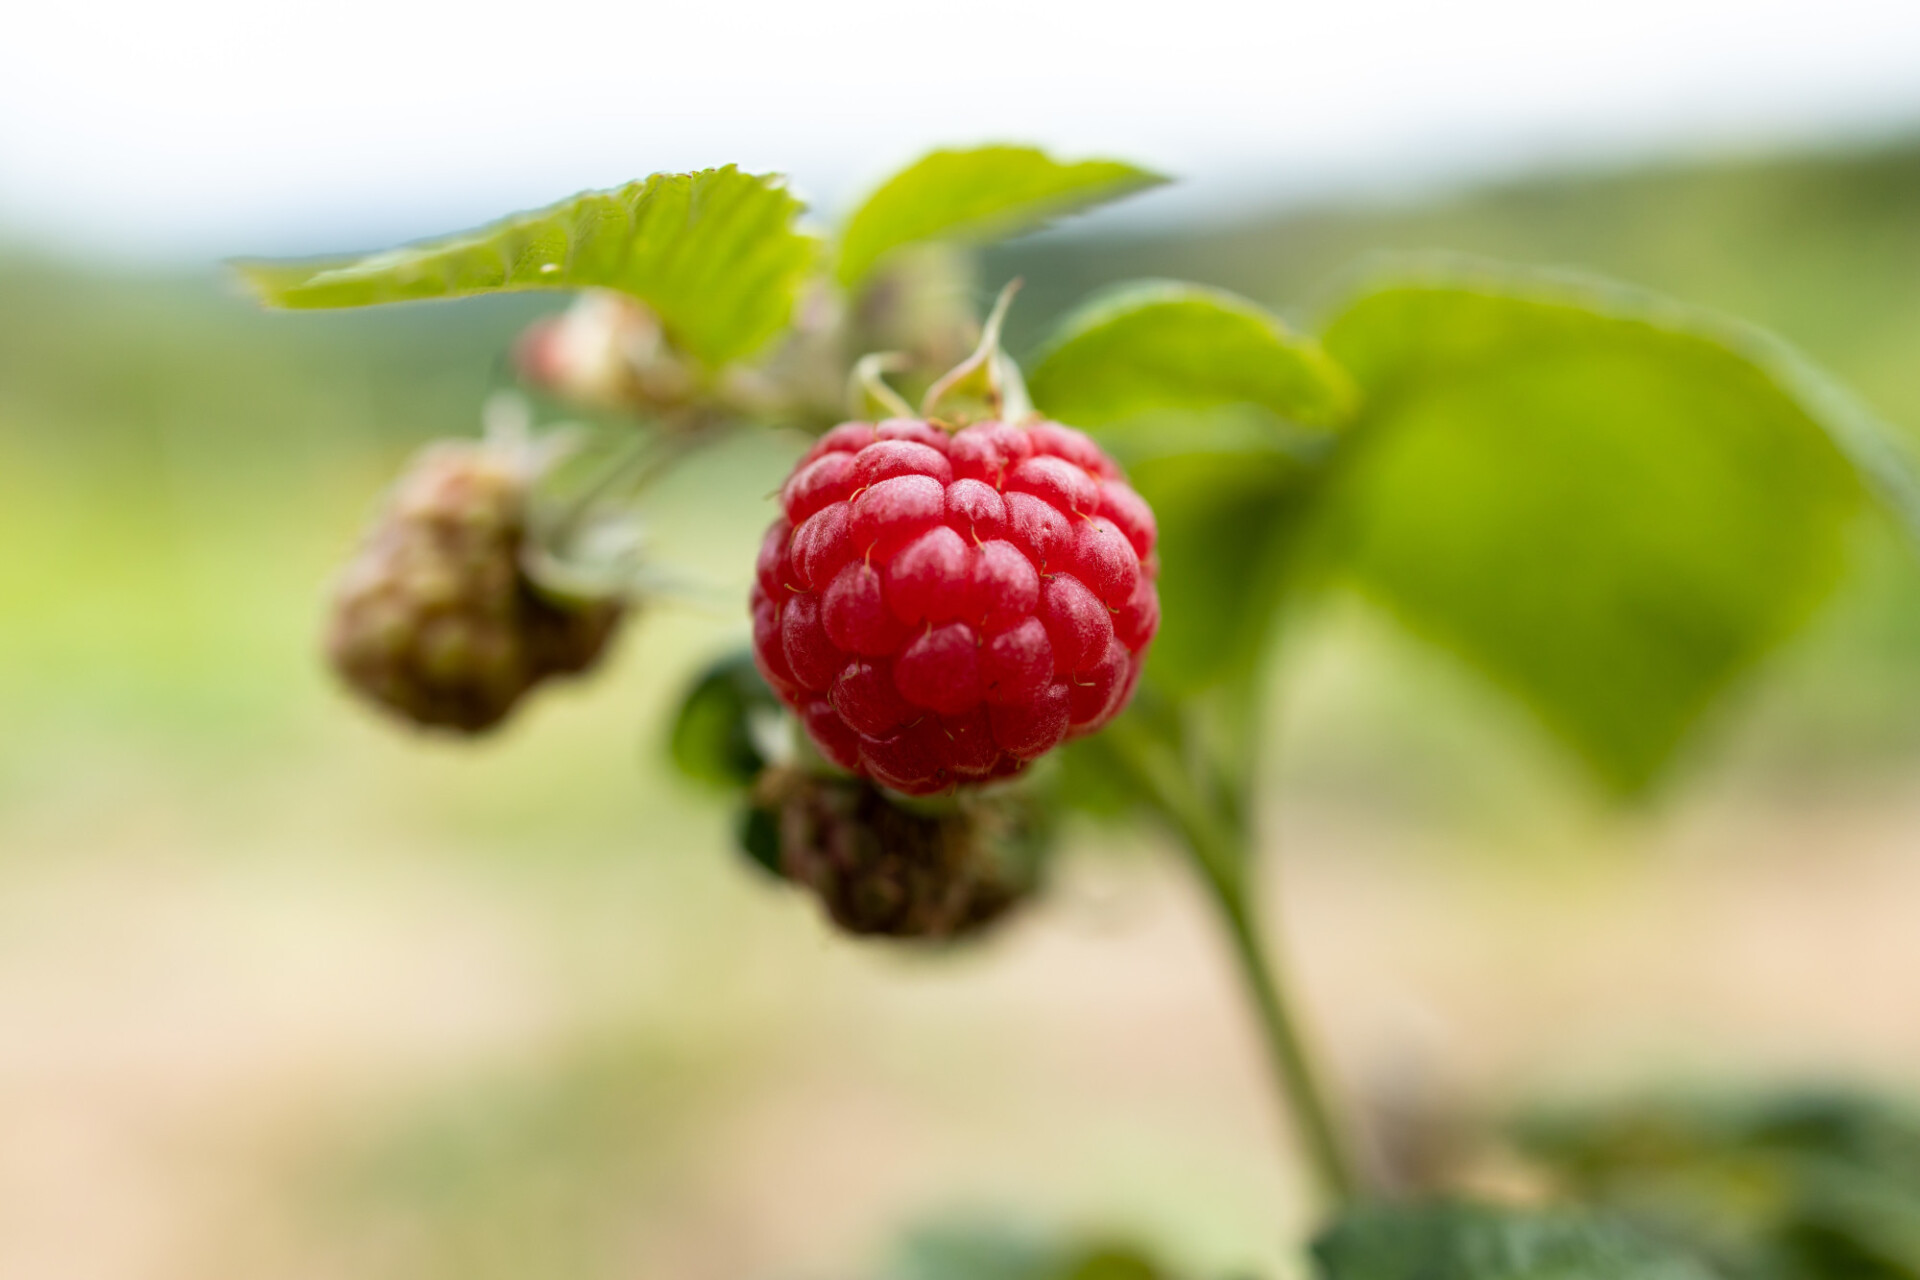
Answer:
(837, 146, 1165, 288)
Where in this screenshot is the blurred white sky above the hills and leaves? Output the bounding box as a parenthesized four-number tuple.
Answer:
(0, 0, 1920, 259)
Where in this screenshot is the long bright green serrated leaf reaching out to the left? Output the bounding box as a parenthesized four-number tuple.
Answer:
(236, 165, 818, 365)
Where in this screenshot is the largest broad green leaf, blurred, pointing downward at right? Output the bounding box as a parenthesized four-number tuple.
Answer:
(1325, 263, 1912, 791)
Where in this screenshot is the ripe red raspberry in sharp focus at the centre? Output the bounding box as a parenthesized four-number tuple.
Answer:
(753, 418, 1160, 794)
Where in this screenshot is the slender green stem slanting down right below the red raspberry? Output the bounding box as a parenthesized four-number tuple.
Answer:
(1116, 731, 1361, 1207)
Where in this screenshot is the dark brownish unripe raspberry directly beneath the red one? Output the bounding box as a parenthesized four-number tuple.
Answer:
(755, 770, 1044, 938)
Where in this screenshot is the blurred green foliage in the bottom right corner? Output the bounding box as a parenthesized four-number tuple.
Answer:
(1519, 1092, 1920, 1280)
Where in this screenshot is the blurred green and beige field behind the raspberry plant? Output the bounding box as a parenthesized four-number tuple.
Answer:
(0, 146, 1920, 1280)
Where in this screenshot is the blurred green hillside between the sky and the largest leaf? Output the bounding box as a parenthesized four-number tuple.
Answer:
(983, 132, 1920, 426)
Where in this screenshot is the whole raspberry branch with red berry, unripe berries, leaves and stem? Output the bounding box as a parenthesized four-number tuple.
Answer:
(240, 146, 1920, 1280)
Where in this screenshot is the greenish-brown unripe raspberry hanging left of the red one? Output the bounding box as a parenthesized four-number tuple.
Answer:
(326, 441, 620, 733)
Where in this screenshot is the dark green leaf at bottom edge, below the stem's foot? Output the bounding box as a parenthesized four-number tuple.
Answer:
(1313, 1203, 1715, 1280)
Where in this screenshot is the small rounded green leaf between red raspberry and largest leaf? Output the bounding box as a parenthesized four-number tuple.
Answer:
(1027, 280, 1357, 428)
